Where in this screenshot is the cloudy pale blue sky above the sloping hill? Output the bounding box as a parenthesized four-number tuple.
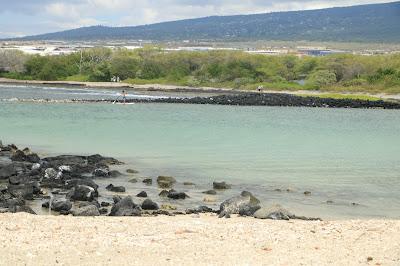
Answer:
(0, 0, 390, 38)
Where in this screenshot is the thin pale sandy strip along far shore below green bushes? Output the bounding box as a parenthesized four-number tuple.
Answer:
(0, 78, 400, 101)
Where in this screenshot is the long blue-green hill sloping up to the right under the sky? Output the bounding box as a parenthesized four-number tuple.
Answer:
(8, 2, 400, 43)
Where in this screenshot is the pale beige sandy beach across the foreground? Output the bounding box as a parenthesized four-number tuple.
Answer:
(0, 214, 400, 265)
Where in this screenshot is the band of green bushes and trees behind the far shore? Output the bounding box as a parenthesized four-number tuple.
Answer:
(0, 47, 400, 96)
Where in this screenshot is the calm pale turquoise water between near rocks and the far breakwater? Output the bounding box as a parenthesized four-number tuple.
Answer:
(0, 84, 400, 218)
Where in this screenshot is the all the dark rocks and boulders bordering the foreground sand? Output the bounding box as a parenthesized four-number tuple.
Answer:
(0, 142, 313, 220)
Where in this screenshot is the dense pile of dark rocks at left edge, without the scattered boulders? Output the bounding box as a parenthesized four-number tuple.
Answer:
(0, 144, 122, 215)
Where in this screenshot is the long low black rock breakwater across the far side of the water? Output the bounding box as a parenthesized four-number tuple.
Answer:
(5, 92, 400, 110)
